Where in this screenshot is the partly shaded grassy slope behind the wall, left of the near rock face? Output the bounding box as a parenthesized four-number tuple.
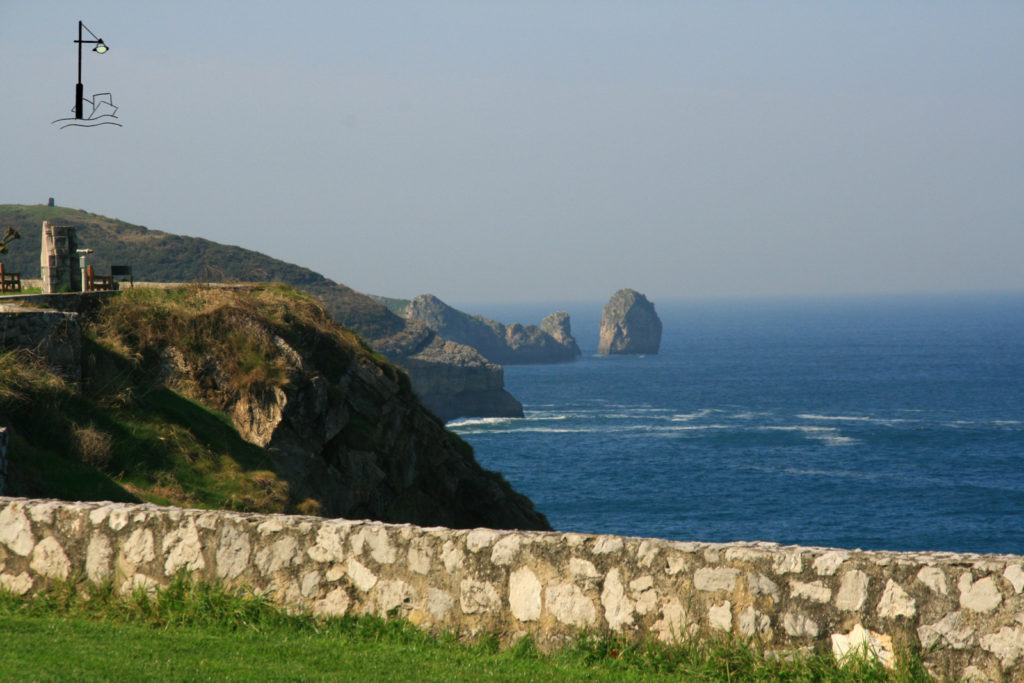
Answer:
(0, 347, 289, 512)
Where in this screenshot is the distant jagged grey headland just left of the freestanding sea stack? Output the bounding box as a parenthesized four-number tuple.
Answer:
(404, 294, 580, 365)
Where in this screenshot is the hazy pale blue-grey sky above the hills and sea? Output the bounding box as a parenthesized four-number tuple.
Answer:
(0, 0, 1024, 302)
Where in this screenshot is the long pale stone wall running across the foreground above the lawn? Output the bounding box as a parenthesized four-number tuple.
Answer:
(0, 498, 1024, 680)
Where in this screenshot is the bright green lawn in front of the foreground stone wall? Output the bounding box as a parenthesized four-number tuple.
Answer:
(0, 577, 930, 681)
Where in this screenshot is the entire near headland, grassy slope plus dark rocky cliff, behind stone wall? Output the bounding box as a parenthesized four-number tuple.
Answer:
(0, 285, 548, 528)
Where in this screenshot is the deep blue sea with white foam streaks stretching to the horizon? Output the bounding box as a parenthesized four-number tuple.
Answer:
(450, 294, 1024, 554)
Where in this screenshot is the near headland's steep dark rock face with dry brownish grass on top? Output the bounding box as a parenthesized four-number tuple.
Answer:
(96, 290, 549, 528)
